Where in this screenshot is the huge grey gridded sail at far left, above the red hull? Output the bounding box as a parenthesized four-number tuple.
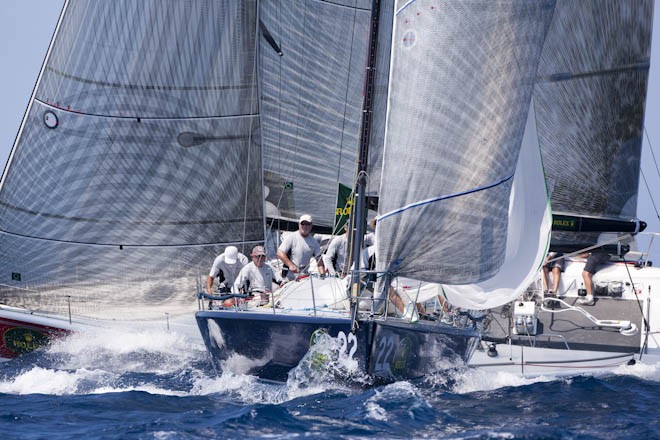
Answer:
(0, 0, 264, 318)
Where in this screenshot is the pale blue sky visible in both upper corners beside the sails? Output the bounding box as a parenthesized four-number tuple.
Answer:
(0, 0, 660, 260)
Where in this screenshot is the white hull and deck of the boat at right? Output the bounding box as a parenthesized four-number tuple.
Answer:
(469, 259, 660, 377)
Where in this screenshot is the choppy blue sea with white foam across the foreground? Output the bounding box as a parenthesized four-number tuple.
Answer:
(0, 324, 660, 440)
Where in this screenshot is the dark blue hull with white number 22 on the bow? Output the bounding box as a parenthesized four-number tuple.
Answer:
(196, 310, 479, 383)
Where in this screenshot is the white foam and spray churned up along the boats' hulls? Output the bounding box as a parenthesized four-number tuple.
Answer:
(0, 327, 660, 402)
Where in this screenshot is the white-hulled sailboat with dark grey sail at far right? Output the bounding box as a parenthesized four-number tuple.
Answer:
(464, 1, 660, 376)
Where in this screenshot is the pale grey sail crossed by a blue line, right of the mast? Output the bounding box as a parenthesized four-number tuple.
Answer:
(377, 1, 554, 284)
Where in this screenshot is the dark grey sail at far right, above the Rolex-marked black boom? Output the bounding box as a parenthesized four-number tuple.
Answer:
(534, 0, 653, 245)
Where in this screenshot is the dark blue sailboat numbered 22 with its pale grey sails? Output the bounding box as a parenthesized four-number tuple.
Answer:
(196, 1, 554, 382)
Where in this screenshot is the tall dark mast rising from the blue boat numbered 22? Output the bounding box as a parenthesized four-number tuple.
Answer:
(351, 0, 380, 327)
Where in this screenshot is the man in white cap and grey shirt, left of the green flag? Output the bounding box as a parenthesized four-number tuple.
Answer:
(277, 214, 325, 280)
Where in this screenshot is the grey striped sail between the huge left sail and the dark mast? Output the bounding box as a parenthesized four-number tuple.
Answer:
(259, 0, 371, 227)
